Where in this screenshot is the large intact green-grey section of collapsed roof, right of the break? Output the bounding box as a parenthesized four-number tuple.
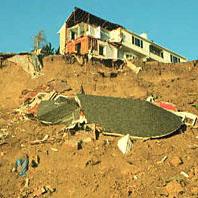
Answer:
(78, 94, 182, 138)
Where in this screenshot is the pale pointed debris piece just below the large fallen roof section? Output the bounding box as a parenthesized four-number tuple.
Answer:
(117, 134, 133, 154)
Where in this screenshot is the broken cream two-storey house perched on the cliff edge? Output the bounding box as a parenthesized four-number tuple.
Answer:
(58, 8, 187, 63)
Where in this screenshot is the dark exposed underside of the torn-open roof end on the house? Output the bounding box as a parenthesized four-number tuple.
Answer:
(66, 7, 122, 30)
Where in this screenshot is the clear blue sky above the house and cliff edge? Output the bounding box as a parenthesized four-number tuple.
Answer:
(0, 0, 198, 60)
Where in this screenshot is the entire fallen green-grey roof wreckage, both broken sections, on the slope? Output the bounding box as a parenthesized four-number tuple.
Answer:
(15, 92, 182, 138)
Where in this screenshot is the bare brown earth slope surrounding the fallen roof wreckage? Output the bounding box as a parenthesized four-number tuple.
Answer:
(0, 56, 198, 198)
